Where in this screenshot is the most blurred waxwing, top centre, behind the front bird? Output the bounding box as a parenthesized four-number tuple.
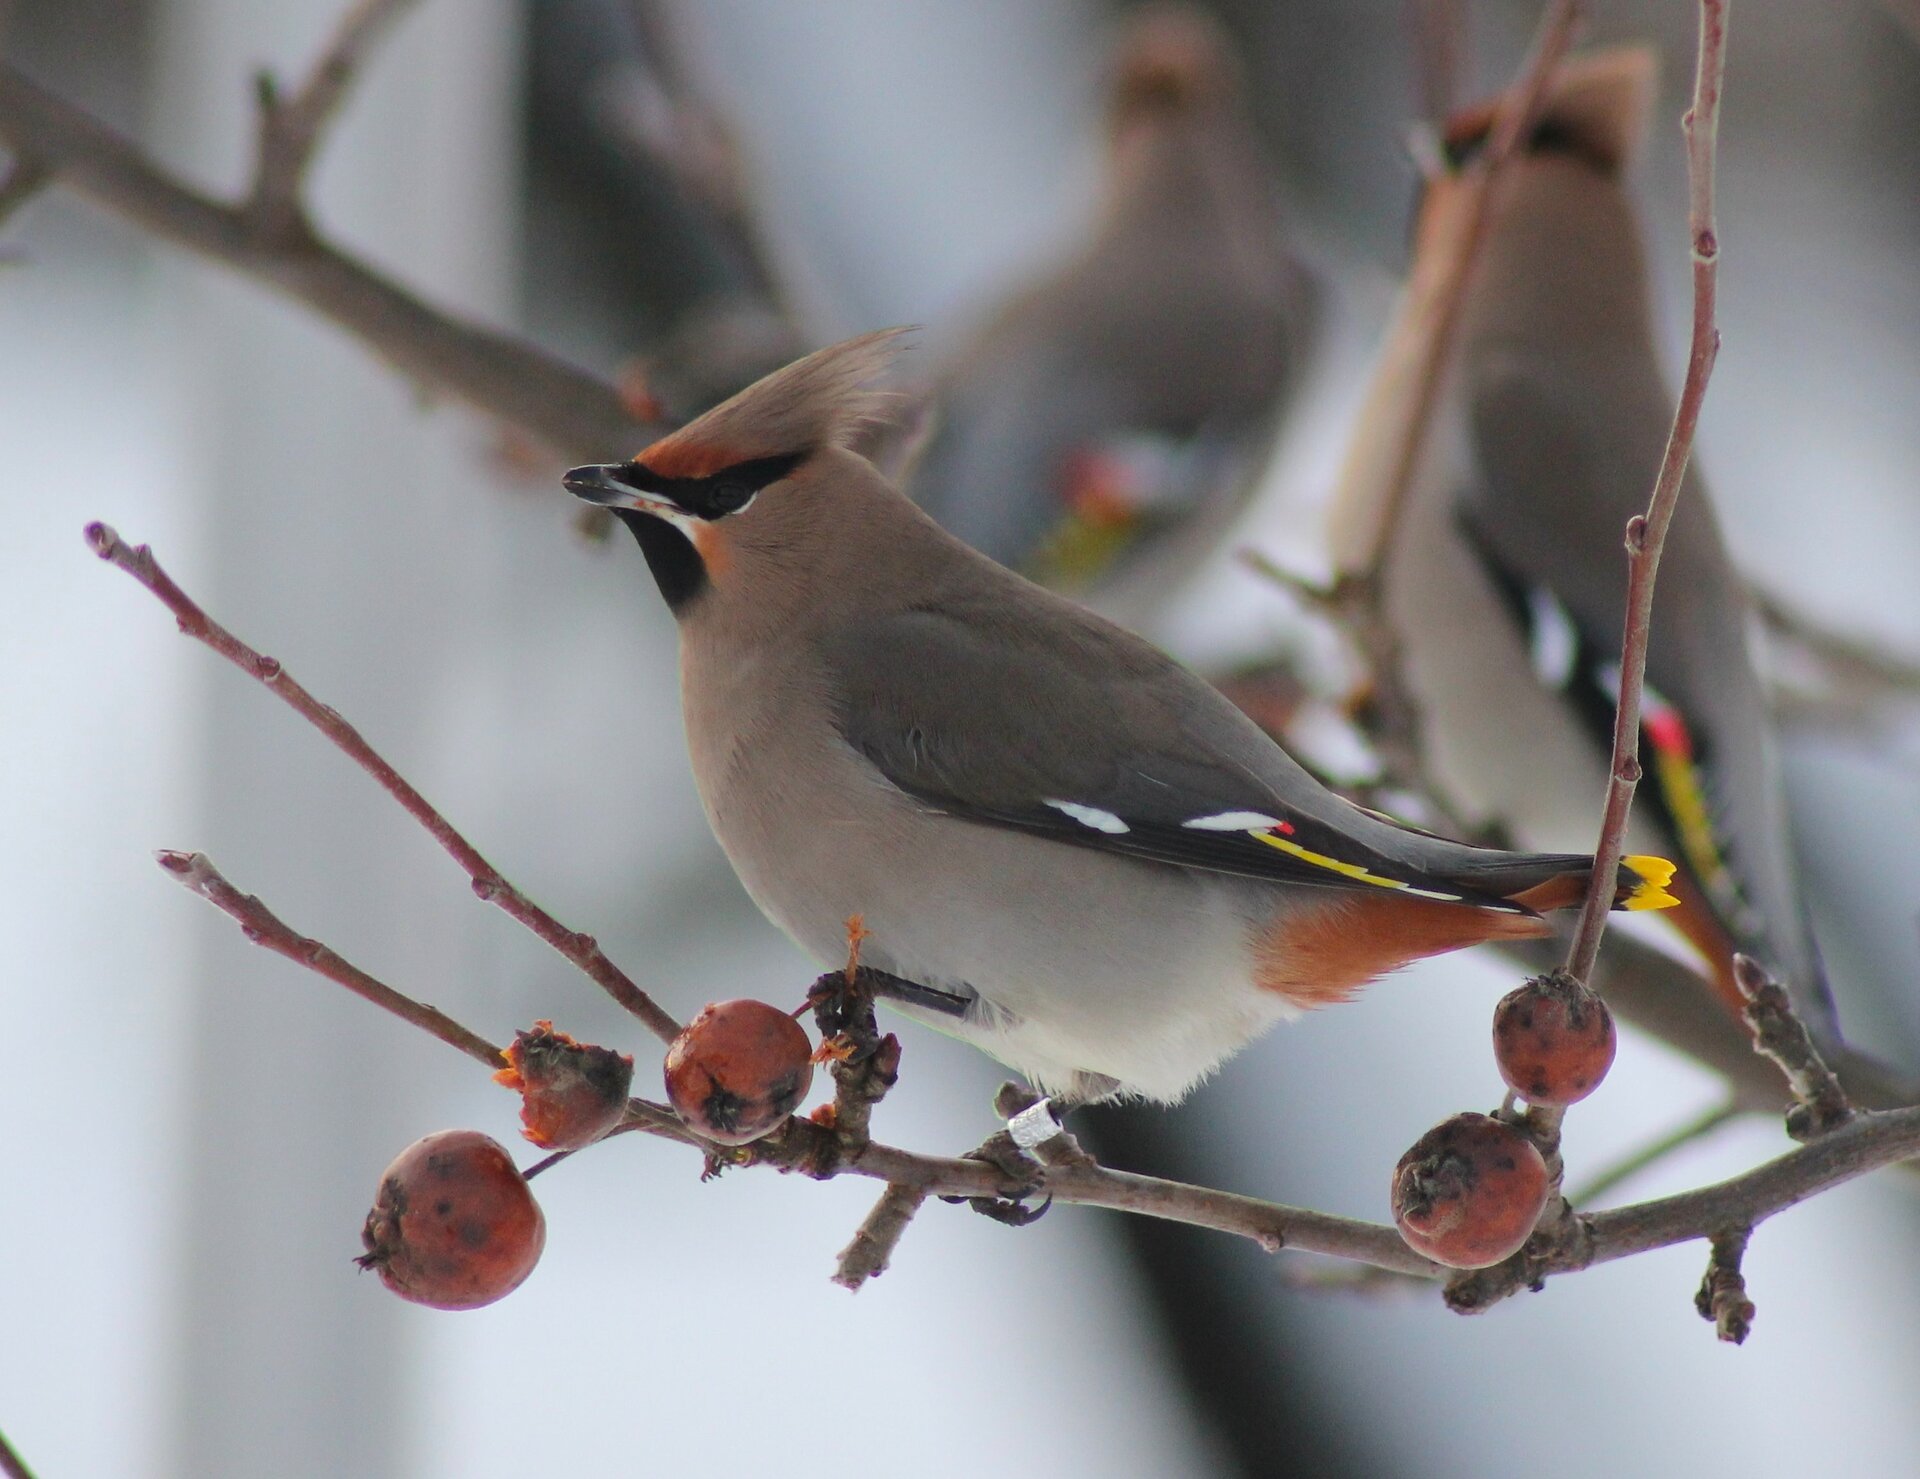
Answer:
(906, 6, 1309, 617)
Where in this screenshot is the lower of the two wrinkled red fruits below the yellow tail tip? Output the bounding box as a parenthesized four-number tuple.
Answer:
(1394, 1114, 1548, 1268)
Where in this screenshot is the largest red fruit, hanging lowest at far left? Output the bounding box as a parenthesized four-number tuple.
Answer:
(355, 1129, 547, 1310)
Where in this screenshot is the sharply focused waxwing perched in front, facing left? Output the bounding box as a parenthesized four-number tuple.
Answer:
(566, 330, 1672, 1101)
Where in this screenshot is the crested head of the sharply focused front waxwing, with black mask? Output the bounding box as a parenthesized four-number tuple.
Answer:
(563, 328, 908, 617)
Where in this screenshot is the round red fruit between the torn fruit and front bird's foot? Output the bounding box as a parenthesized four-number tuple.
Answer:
(666, 1001, 814, 1145)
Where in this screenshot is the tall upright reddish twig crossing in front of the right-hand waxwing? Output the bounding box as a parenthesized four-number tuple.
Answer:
(1567, 0, 1730, 982)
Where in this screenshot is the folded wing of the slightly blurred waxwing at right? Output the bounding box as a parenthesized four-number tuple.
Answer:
(1461, 361, 1832, 1024)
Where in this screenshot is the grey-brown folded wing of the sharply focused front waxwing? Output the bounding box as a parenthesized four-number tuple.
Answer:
(829, 591, 1551, 912)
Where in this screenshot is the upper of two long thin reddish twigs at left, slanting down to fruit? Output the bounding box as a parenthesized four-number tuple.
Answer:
(86, 524, 680, 1043)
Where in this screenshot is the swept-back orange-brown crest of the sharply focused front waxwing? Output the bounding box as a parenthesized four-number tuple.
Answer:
(634, 328, 912, 478)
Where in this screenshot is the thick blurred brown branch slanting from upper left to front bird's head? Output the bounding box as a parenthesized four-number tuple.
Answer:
(0, 63, 660, 457)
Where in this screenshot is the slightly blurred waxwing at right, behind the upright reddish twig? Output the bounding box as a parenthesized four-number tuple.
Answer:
(1332, 48, 1837, 1064)
